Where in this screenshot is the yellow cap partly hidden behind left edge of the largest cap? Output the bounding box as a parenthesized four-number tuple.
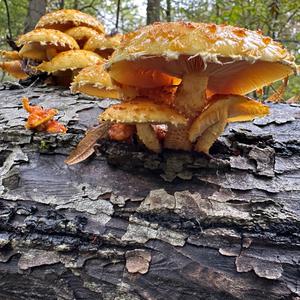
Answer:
(71, 64, 120, 99)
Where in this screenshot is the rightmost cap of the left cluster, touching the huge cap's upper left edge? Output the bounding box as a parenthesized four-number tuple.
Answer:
(83, 34, 122, 58)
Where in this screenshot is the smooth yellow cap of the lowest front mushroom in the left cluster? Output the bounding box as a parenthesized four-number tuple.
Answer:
(36, 50, 104, 73)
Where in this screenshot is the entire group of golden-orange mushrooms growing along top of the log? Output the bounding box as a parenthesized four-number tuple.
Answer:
(0, 10, 297, 153)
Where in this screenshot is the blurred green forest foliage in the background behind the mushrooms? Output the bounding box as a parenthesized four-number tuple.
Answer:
(0, 0, 300, 98)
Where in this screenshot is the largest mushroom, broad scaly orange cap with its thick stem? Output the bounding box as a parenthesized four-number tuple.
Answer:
(108, 22, 297, 152)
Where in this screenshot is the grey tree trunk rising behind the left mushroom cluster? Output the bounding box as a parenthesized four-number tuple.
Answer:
(24, 0, 47, 33)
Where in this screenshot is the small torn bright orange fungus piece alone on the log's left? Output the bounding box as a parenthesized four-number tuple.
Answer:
(22, 98, 67, 133)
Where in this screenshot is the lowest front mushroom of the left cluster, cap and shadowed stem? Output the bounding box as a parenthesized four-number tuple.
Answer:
(36, 50, 104, 85)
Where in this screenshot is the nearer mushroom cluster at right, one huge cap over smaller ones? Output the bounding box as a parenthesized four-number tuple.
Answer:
(99, 22, 297, 153)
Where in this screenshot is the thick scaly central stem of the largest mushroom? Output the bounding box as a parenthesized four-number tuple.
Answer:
(164, 72, 208, 151)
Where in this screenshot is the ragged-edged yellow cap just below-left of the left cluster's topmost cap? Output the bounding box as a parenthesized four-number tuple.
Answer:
(16, 28, 79, 49)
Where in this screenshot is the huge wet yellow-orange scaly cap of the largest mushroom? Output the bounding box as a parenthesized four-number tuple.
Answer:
(109, 22, 297, 95)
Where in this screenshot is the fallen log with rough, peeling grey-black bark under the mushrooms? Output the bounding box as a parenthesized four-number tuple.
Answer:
(0, 85, 300, 300)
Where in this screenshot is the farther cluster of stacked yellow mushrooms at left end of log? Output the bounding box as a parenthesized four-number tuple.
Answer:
(0, 9, 121, 90)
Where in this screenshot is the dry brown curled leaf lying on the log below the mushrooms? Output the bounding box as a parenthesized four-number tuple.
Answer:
(65, 122, 110, 165)
